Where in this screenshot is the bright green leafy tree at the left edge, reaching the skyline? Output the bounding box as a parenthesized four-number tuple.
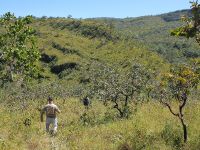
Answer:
(0, 12, 40, 81)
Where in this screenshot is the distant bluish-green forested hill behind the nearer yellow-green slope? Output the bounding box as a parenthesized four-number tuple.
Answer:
(91, 10, 200, 63)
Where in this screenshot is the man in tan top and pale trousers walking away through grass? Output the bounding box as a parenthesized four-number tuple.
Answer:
(40, 97, 60, 134)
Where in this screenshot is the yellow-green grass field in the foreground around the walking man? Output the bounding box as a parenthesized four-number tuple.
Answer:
(0, 98, 200, 150)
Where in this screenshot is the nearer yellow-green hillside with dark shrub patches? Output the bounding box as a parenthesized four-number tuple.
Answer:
(29, 18, 167, 79)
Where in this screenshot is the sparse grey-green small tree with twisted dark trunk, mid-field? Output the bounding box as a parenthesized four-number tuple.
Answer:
(89, 63, 149, 118)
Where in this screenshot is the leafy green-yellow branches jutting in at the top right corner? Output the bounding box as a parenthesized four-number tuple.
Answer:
(171, 0, 200, 44)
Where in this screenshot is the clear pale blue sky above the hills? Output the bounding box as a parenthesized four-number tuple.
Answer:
(0, 0, 190, 18)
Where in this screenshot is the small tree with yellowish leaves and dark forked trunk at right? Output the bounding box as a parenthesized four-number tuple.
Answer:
(159, 66, 200, 142)
